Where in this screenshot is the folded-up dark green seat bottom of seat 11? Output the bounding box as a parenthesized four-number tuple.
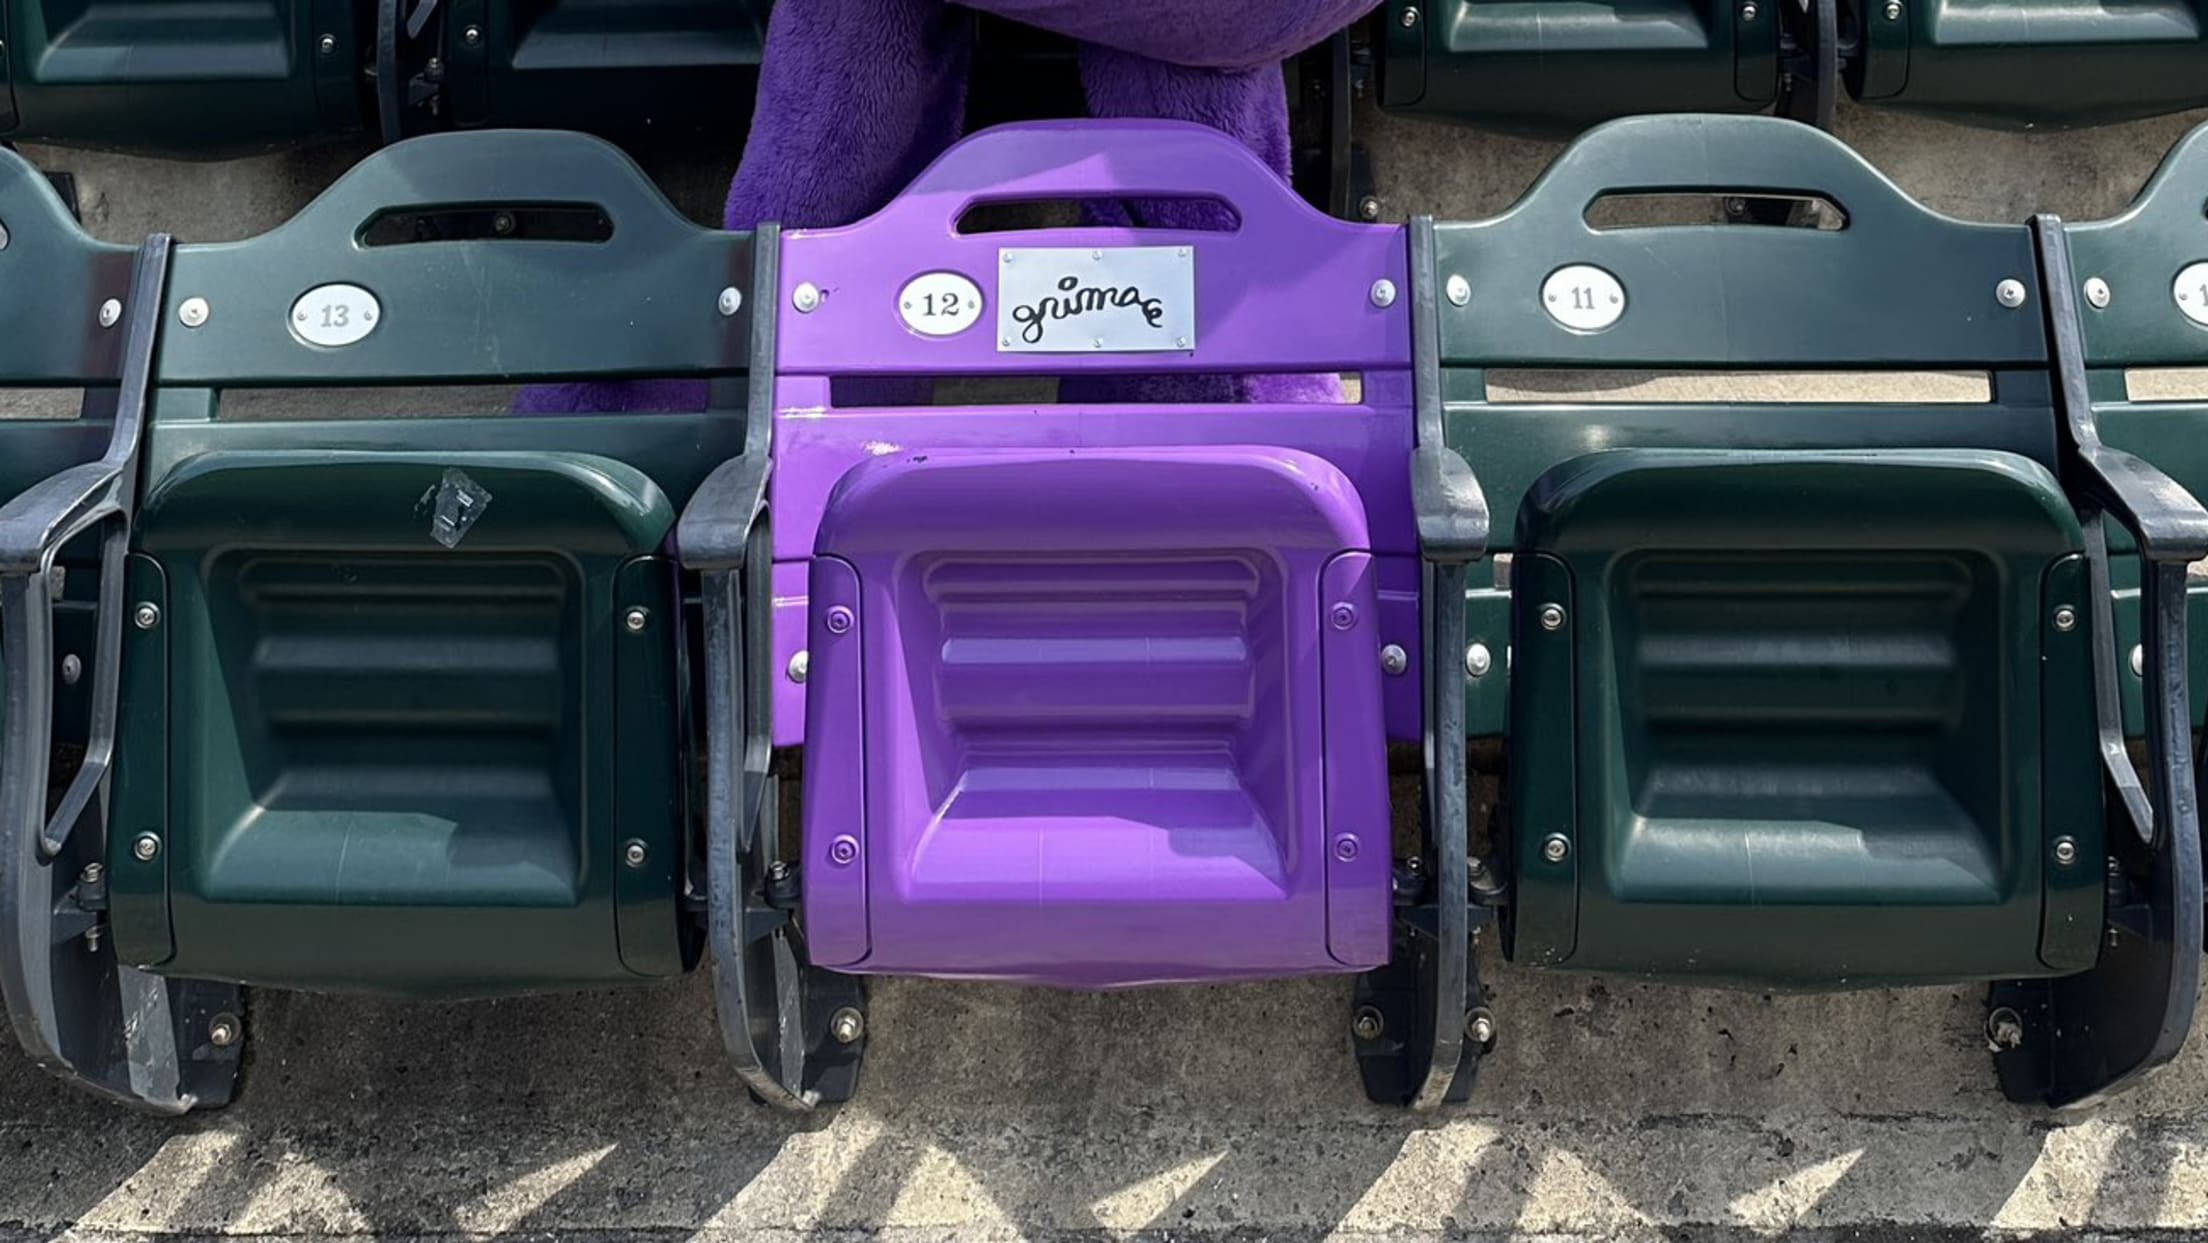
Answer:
(1512, 450, 2100, 987)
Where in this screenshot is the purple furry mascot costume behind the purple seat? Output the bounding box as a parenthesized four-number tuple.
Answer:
(519, 0, 1378, 413)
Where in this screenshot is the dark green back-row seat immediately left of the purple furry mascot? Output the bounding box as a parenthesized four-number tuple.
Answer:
(444, 0, 768, 141)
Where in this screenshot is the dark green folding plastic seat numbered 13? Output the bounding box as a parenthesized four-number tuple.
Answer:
(110, 130, 755, 994)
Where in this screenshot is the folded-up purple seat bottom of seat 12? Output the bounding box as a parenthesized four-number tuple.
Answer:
(804, 448, 1387, 987)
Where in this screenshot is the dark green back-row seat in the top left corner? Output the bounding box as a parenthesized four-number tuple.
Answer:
(0, 0, 373, 155)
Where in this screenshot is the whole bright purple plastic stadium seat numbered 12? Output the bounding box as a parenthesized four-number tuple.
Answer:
(771, 121, 1418, 987)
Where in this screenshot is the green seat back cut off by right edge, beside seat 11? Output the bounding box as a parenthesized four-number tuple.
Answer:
(2062, 120, 2208, 737)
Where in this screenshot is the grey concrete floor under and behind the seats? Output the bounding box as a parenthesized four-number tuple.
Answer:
(0, 92, 2208, 1243)
